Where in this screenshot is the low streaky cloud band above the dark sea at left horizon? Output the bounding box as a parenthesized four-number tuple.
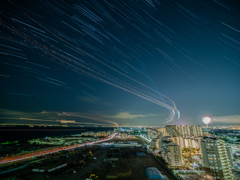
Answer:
(0, 109, 158, 126)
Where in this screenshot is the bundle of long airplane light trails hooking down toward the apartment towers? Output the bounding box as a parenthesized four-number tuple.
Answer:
(1, 4, 180, 123)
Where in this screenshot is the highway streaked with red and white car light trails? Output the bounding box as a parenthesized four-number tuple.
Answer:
(0, 133, 117, 165)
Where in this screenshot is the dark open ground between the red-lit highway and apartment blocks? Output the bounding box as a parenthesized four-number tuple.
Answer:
(0, 136, 176, 180)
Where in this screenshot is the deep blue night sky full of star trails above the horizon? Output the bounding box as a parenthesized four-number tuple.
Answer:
(0, 0, 240, 126)
